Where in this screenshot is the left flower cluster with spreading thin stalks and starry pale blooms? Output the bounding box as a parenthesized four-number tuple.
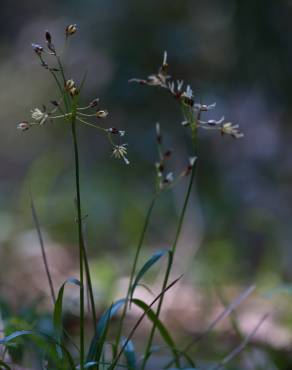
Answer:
(17, 24, 130, 164)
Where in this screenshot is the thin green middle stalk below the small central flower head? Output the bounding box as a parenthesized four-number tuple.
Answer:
(116, 193, 158, 348)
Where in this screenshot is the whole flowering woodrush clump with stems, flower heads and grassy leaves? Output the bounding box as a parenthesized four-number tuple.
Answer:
(0, 24, 266, 370)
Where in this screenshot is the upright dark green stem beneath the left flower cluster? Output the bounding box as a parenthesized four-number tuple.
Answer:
(71, 104, 84, 370)
